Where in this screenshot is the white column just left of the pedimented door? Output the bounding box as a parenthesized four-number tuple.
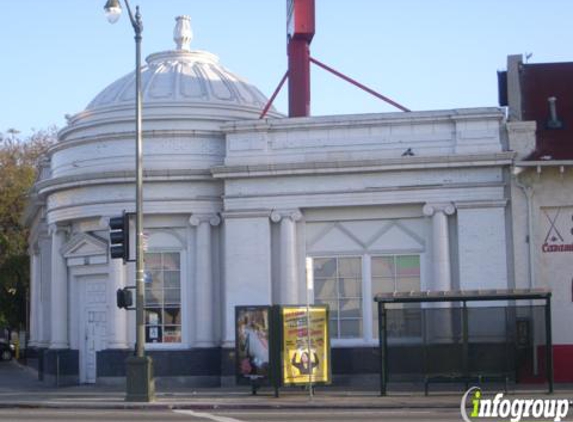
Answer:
(50, 224, 69, 349)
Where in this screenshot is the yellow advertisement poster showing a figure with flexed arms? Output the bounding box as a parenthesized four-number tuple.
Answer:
(281, 306, 330, 384)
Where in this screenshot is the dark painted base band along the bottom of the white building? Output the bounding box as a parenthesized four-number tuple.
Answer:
(30, 344, 540, 390)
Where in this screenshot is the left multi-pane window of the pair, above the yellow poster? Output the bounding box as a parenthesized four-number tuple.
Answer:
(313, 257, 362, 338)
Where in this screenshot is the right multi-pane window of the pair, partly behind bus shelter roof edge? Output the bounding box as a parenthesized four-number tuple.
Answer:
(372, 255, 421, 337)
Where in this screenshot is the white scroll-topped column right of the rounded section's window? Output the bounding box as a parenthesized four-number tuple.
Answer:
(189, 214, 221, 347)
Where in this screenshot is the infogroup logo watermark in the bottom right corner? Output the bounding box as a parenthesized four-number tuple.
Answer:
(460, 387, 570, 422)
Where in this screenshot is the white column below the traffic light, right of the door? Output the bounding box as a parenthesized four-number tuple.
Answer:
(107, 259, 129, 349)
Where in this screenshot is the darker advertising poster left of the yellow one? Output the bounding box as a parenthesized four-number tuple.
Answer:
(235, 306, 270, 381)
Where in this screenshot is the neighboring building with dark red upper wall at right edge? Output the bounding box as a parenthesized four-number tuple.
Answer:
(499, 56, 573, 382)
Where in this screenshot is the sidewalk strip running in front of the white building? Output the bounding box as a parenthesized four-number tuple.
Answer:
(0, 362, 573, 410)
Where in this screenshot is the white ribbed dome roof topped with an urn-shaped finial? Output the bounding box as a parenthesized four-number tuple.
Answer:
(78, 16, 276, 117)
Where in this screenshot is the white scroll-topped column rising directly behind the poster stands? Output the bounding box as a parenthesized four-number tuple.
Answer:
(271, 210, 302, 305)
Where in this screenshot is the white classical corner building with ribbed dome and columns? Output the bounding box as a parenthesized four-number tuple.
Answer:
(27, 15, 514, 385)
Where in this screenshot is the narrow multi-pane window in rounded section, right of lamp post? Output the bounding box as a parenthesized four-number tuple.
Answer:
(145, 252, 181, 343)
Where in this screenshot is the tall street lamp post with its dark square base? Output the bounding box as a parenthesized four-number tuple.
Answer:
(104, 0, 155, 402)
